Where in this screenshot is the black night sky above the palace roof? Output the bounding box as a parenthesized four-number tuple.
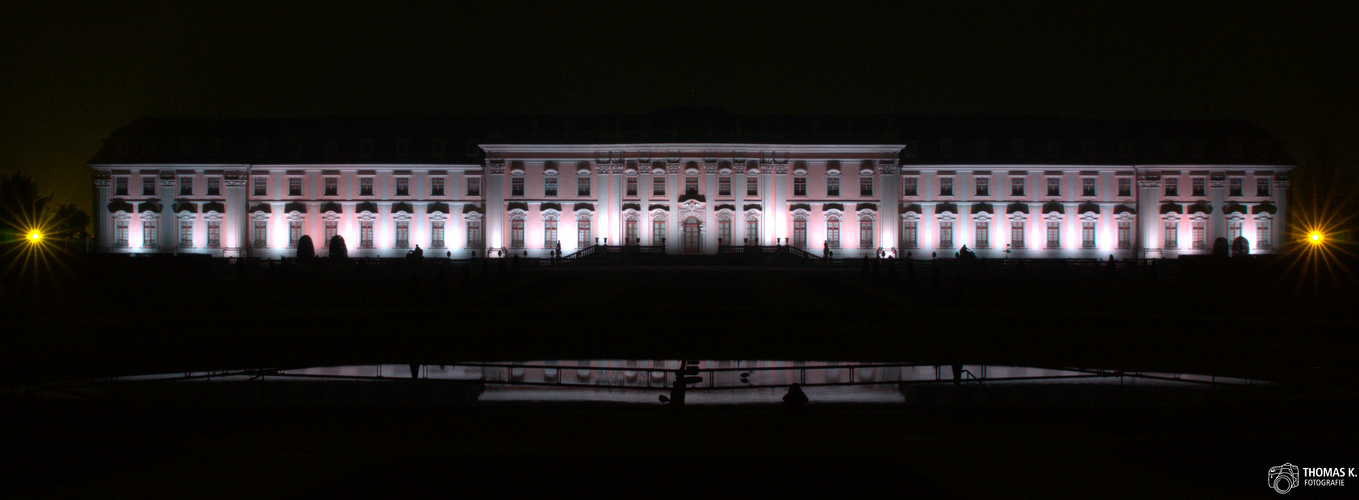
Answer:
(0, 1, 1359, 216)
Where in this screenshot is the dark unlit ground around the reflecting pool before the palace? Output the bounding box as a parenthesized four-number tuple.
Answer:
(0, 255, 1359, 497)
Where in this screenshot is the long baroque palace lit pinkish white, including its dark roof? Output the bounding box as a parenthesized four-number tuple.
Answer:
(90, 107, 1294, 258)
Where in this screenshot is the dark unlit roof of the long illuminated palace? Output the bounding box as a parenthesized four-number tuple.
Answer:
(90, 107, 1294, 164)
